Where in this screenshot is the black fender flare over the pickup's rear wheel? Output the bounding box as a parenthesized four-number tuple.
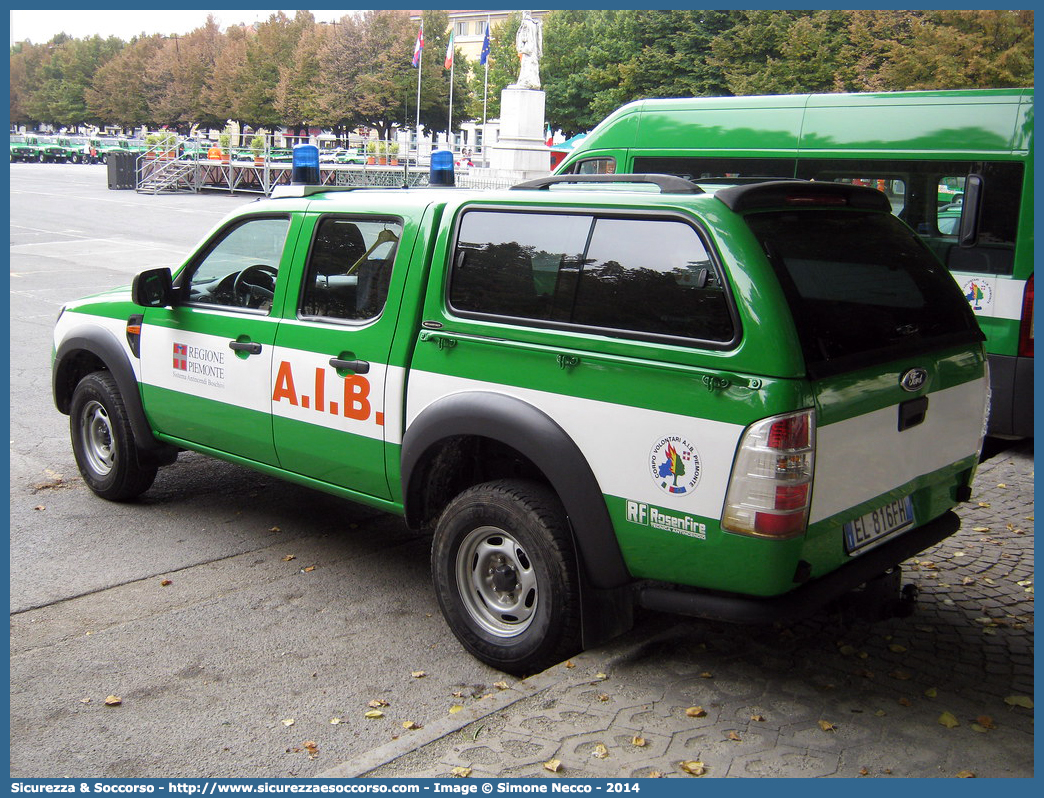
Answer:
(401, 392, 633, 589)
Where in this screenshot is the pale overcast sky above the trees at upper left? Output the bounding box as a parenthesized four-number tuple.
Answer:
(3, 4, 371, 44)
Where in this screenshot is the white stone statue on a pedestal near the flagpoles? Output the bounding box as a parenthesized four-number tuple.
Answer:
(490, 11, 551, 180)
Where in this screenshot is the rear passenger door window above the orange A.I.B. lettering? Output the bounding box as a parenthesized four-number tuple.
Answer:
(300, 216, 402, 321)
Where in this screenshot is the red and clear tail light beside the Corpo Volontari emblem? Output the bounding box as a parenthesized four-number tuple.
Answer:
(721, 409, 815, 539)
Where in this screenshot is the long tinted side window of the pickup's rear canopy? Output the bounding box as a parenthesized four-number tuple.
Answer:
(449, 211, 735, 343)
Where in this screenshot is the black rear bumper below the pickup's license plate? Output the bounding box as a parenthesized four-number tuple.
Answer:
(637, 512, 960, 624)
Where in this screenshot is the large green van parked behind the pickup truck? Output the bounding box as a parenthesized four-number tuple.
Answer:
(556, 89, 1034, 438)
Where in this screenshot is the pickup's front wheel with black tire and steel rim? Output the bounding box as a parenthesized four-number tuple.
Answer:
(69, 371, 157, 501)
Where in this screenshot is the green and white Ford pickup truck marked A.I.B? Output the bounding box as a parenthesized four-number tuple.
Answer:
(53, 174, 988, 673)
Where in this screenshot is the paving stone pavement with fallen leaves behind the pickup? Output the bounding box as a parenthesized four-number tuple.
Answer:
(322, 441, 1034, 778)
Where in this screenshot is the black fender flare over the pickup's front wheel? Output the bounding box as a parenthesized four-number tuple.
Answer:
(51, 325, 176, 463)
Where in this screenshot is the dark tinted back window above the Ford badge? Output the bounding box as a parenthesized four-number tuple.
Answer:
(746, 210, 982, 376)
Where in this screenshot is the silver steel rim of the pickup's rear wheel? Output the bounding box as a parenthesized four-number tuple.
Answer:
(456, 526, 539, 638)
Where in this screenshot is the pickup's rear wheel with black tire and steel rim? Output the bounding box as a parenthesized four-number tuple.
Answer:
(431, 479, 580, 674)
